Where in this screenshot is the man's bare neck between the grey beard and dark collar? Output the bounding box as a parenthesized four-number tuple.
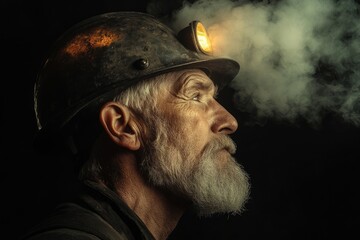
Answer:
(116, 157, 185, 240)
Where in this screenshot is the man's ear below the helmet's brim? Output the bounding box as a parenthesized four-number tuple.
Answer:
(100, 102, 140, 151)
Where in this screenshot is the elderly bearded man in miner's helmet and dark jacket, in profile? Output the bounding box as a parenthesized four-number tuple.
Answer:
(24, 12, 249, 240)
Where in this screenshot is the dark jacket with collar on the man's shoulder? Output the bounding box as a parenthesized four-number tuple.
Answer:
(22, 181, 154, 240)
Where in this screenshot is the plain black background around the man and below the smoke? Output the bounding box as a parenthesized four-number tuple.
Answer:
(0, 0, 360, 239)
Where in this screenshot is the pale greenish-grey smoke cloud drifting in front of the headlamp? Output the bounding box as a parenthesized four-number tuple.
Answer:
(155, 0, 360, 126)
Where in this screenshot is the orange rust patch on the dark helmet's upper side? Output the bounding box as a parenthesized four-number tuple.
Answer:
(64, 29, 120, 57)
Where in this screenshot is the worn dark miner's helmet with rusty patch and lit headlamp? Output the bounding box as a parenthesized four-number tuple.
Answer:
(34, 12, 240, 148)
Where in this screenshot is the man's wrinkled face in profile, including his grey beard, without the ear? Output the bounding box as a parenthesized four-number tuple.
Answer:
(143, 70, 249, 215)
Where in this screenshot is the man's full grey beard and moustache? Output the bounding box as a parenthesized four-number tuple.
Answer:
(142, 118, 250, 216)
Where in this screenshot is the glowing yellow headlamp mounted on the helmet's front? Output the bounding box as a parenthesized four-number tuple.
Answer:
(178, 21, 213, 55)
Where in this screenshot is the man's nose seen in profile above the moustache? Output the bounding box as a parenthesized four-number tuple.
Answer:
(211, 103, 238, 134)
